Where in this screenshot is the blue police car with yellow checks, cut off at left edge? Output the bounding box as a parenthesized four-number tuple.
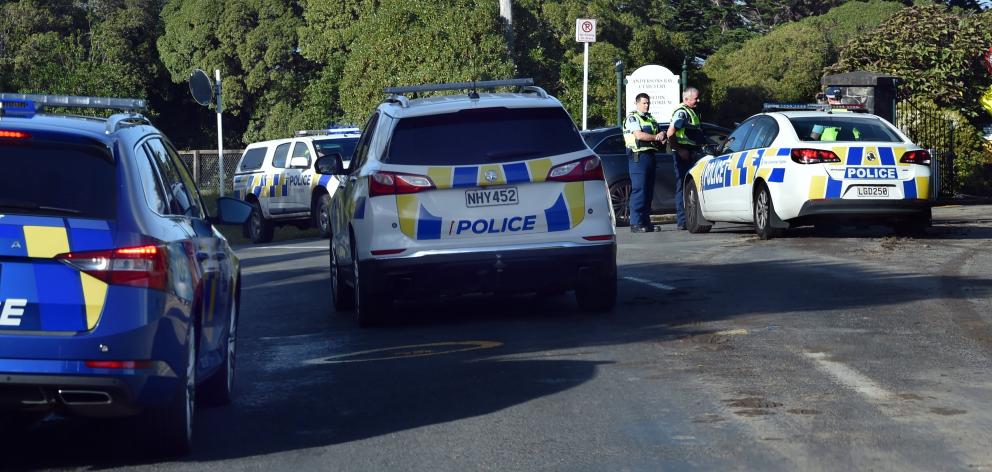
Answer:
(0, 94, 251, 454)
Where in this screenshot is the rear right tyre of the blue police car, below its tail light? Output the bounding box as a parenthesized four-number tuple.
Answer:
(141, 321, 198, 457)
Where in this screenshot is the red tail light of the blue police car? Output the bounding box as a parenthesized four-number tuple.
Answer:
(56, 246, 169, 290)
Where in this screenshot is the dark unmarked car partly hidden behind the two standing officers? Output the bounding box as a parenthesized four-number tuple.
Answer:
(581, 123, 730, 225)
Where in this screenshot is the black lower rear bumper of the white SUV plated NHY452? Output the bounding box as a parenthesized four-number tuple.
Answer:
(359, 242, 617, 298)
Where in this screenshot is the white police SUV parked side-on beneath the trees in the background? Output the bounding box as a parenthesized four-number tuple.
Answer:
(234, 128, 359, 243)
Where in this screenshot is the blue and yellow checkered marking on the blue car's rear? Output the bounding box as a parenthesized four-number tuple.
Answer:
(0, 215, 113, 332)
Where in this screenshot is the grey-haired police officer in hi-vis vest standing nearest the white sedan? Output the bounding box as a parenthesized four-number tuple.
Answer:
(667, 87, 704, 229)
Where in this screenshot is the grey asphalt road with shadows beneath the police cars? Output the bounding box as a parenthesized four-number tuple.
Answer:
(7, 206, 992, 471)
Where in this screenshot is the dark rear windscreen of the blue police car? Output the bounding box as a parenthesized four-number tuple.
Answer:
(0, 142, 117, 220)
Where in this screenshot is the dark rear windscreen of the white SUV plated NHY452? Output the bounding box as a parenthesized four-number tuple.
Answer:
(383, 107, 586, 165)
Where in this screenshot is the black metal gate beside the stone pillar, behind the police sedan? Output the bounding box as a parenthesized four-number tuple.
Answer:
(895, 100, 955, 197)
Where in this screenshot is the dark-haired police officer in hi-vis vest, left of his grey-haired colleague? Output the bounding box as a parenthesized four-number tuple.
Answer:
(623, 93, 666, 233)
